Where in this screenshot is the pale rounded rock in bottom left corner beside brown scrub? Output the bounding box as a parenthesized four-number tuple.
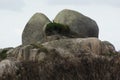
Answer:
(0, 59, 19, 80)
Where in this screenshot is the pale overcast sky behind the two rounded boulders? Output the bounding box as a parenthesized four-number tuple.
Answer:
(0, 0, 120, 50)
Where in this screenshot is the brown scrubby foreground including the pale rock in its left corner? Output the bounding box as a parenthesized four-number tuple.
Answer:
(0, 50, 120, 80)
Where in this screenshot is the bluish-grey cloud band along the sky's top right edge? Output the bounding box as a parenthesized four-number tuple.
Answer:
(45, 0, 120, 6)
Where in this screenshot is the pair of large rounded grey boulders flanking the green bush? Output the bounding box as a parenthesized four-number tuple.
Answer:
(22, 9, 99, 45)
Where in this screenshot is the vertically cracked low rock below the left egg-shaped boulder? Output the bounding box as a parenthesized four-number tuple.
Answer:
(7, 45, 46, 61)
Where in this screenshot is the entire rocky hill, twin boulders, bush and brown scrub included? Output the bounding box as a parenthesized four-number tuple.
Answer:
(0, 10, 120, 80)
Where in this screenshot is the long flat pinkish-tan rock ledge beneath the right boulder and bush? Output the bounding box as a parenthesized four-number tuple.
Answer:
(42, 38, 102, 55)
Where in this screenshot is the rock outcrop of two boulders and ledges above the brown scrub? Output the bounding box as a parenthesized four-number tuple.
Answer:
(2, 9, 116, 60)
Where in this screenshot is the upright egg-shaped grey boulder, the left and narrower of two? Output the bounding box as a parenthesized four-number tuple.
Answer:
(22, 13, 50, 45)
